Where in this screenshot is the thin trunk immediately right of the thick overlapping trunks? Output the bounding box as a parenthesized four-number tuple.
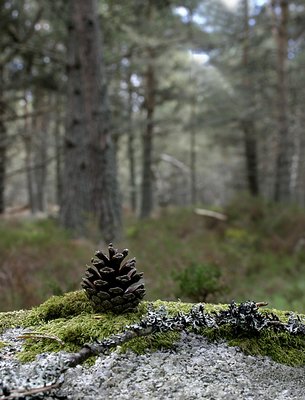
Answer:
(127, 71, 137, 213)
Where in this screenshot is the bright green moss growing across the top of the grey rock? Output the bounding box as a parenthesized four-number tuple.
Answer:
(0, 291, 305, 366)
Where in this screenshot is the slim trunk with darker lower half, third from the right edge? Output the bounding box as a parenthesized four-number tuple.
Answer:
(241, 0, 259, 196)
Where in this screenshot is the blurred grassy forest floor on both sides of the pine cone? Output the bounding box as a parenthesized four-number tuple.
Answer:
(0, 193, 305, 313)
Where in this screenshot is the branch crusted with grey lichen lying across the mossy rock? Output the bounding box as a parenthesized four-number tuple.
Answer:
(68, 301, 305, 367)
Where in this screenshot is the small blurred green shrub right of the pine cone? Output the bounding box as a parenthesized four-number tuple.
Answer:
(174, 264, 223, 302)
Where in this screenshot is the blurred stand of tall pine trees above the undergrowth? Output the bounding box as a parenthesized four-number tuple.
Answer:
(0, 0, 305, 241)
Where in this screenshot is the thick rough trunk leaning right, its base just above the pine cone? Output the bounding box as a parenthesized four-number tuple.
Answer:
(72, 0, 121, 241)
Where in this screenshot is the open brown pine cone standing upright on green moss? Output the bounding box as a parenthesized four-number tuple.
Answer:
(81, 243, 145, 314)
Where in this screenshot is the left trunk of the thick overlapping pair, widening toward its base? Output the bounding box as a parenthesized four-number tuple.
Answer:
(60, 0, 92, 236)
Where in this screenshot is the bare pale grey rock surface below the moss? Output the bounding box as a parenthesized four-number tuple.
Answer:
(0, 329, 305, 400)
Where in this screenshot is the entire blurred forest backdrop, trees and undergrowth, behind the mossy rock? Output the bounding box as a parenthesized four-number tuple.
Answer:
(0, 0, 305, 312)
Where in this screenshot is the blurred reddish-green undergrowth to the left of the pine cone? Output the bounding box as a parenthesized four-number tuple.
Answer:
(0, 220, 93, 311)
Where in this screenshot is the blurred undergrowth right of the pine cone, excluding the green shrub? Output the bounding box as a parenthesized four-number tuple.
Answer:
(124, 196, 305, 312)
